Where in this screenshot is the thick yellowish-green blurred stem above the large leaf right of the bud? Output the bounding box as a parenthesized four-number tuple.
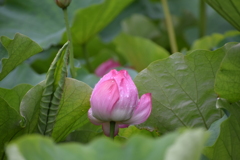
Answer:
(161, 0, 178, 53)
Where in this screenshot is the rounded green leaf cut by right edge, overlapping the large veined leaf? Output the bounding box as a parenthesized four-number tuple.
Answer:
(215, 43, 240, 102)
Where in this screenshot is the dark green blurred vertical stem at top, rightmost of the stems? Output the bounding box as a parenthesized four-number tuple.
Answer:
(199, 0, 206, 38)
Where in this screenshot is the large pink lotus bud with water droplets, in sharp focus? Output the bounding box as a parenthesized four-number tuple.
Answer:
(88, 70, 152, 136)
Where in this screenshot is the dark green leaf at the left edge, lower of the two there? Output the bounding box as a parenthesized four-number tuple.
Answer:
(0, 97, 23, 159)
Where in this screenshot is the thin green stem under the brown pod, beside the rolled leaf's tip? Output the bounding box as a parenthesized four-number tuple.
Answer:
(63, 8, 76, 78)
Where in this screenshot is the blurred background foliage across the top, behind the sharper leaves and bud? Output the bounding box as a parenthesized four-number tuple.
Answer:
(0, 0, 236, 88)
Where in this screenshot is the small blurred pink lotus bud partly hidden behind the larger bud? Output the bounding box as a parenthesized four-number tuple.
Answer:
(95, 59, 121, 77)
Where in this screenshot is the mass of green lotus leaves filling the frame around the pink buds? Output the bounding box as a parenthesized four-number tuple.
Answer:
(0, 0, 240, 160)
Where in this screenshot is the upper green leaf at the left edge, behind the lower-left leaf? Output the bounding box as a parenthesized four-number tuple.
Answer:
(0, 84, 32, 113)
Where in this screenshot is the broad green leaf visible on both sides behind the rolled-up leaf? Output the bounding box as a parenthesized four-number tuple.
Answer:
(20, 78, 92, 141)
